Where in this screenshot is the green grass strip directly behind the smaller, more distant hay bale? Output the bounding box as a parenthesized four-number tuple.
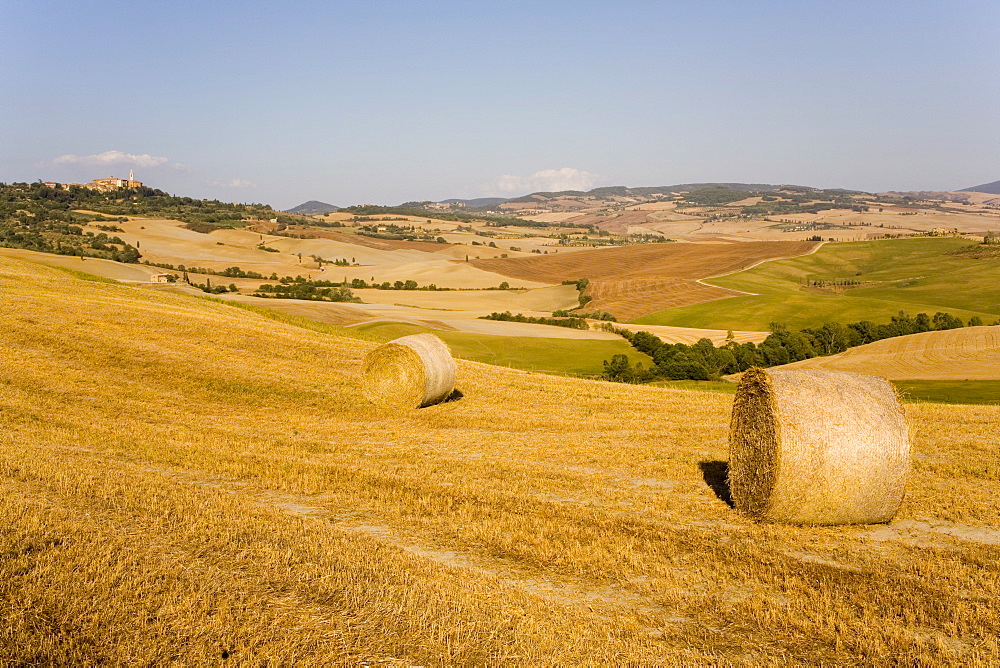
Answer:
(346, 323, 653, 376)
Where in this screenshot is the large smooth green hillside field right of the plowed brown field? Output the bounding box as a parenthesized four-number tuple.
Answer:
(633, 238, 1000, 330)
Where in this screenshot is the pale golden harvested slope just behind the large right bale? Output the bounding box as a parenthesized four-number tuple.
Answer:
(782, 327, 1000, 380)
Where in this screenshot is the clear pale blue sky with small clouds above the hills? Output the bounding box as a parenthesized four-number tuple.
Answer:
(0, 0, 1000, 208)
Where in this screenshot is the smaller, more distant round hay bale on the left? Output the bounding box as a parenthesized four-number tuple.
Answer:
(361, 334, 455, 408)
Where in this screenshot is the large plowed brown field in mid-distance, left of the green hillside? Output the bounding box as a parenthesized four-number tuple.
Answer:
(471, 241, 816, 320)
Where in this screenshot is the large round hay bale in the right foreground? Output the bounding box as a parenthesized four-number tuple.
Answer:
(729, 369, 910, 524)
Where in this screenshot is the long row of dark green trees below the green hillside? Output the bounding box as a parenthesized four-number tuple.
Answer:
(604, 311, 988, 383)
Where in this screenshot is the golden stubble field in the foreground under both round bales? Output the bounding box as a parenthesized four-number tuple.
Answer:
(0, 260, 1000, 665)
